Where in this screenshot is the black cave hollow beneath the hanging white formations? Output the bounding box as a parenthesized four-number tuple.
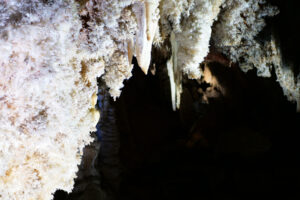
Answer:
(56, 57, 300, 200)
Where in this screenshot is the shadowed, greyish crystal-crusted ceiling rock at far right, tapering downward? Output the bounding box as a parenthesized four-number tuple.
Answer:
(212, 0, 300, 111)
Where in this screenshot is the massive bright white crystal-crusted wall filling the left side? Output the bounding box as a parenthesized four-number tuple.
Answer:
(0, 1, 104, 200)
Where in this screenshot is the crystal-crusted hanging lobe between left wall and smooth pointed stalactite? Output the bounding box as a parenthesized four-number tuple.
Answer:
(80, 0, 137, 97)
